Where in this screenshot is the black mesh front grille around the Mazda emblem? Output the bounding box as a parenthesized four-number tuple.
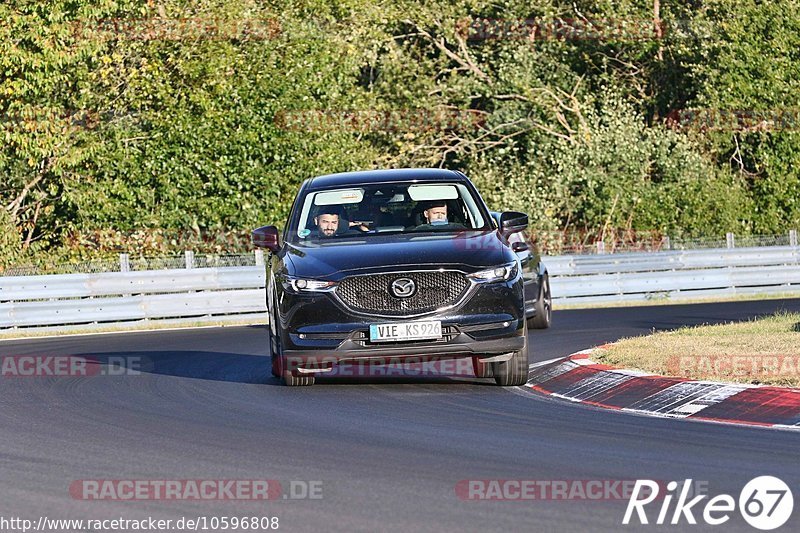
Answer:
(336, 270, 469, 316)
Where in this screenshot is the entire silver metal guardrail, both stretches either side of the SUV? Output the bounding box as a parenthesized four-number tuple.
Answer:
(0, 246, 800, 331)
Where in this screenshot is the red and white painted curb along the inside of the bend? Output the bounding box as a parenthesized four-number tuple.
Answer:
(525, 347, 800, 430)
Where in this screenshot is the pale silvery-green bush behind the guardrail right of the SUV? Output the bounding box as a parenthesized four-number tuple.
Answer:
(474, 92, 750, 236)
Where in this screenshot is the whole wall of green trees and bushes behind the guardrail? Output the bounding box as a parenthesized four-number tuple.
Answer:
(0, 0, 800, 263)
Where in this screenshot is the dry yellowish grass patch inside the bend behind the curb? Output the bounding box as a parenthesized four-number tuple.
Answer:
(592, 312, 800, 387)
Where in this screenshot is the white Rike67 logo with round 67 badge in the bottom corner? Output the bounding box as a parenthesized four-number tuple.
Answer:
(622, 476, 794, 531)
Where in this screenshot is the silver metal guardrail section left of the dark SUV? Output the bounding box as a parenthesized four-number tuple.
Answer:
(0, 266, 266, 330)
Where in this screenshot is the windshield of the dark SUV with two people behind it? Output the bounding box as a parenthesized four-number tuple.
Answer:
(290, 182, 491, 242)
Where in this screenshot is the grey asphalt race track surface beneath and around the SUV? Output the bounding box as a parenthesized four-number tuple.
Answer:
(0, 300, 800, 531)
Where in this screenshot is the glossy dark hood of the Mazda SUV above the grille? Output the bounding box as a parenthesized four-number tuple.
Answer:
(286, 230, 516, 280)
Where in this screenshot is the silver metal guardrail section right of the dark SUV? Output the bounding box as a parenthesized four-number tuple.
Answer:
(544, 246, 800, 304)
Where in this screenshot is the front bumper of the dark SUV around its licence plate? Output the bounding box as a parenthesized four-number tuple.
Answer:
(279, 277, 525, 373)
